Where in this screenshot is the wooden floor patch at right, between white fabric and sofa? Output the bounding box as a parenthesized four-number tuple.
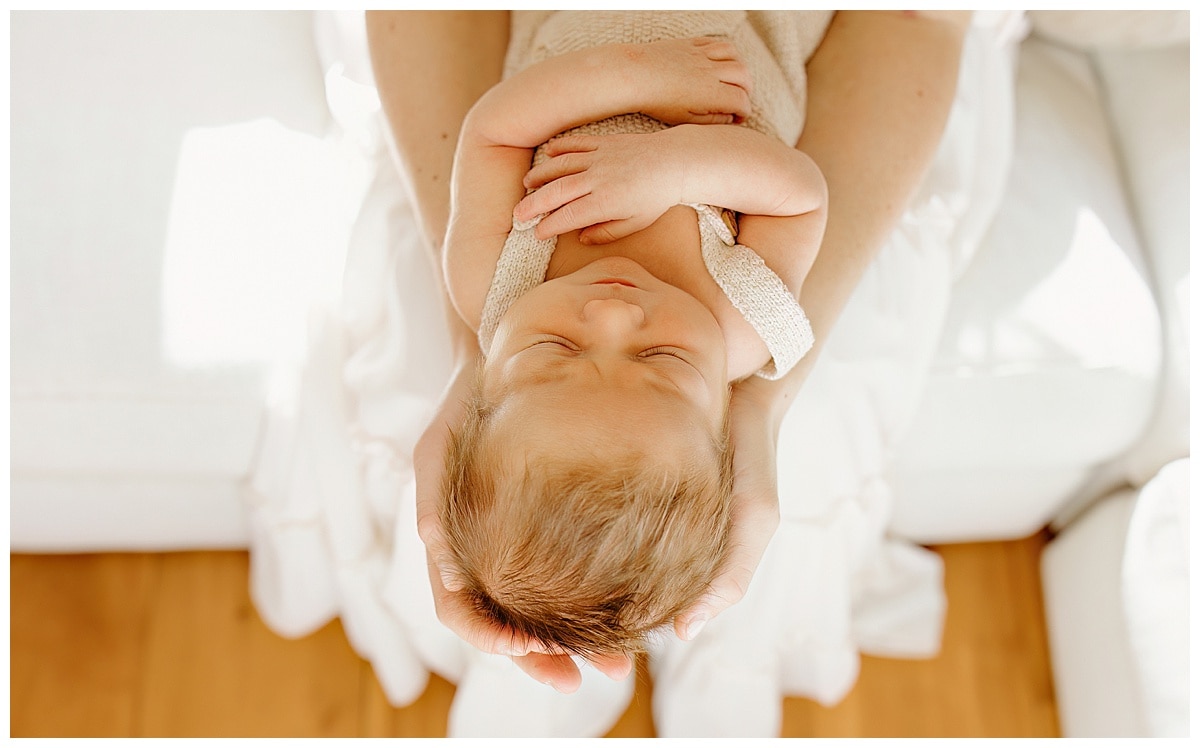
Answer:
(782, 534, 1061, 737)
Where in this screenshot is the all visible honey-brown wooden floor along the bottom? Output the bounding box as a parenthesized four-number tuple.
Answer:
(10, 535, 1058, 737)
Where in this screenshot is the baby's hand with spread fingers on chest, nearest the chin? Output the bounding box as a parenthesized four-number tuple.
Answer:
(512, 131, 686, 244)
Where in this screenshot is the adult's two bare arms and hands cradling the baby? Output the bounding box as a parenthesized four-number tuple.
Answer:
(367, 12, 970, 692)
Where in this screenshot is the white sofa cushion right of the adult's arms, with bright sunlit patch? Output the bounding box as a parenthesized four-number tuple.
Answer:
(892, 38, 1160, 541)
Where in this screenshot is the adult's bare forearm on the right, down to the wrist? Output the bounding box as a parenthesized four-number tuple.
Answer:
(739, 11, 970, 425)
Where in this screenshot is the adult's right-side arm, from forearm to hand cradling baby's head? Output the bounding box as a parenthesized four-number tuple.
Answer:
(676, 11, 970, 639)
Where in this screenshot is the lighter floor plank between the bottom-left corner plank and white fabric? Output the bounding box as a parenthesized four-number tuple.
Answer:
(134, 552, 361, 737)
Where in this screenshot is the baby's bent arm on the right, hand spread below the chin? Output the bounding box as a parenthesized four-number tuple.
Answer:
(514, 125, 827, 298)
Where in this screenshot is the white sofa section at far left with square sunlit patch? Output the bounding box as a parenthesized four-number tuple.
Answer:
(10, 12, 330, 550)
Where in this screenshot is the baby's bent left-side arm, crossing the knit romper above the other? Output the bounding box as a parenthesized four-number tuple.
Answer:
(443, 37, 750, 324)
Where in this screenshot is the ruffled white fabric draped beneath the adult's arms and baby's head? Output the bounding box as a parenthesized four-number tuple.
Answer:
(246, 13, 1012, 737)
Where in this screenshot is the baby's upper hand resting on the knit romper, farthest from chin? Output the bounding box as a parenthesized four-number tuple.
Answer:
(626, 36, 750, 125)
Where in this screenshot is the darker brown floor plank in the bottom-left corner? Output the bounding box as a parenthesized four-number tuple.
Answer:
(8, 555, 160, 737)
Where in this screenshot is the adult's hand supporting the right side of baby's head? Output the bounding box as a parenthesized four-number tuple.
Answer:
(674, 384, 779, 640)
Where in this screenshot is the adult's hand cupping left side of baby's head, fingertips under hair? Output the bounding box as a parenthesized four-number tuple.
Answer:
(413, 359, 634, 693)
